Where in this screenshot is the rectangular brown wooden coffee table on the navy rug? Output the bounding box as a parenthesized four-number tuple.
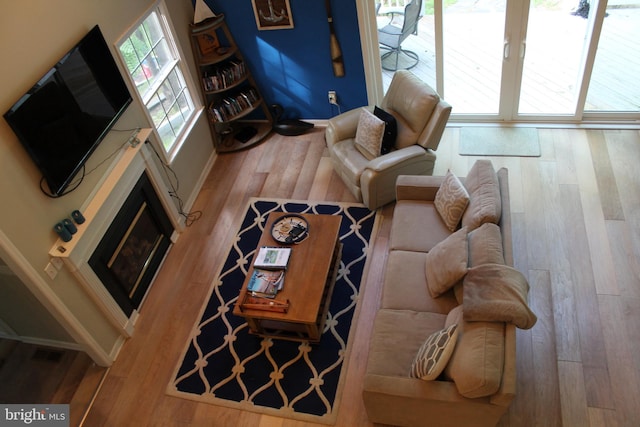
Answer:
(233, 212, 342, 342)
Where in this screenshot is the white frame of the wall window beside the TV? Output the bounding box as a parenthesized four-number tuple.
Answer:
(115, 0, 204, 164)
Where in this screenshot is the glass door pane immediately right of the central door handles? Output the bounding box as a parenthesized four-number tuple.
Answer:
(518, 0, 588, 116)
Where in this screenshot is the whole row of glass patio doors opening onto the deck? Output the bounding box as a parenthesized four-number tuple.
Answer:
(370, 0, 640, 123)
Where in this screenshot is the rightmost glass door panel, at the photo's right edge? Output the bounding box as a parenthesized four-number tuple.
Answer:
(584, 6, 640, 112)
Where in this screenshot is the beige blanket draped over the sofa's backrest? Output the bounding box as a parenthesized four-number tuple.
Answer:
(463, 264, 537, 329)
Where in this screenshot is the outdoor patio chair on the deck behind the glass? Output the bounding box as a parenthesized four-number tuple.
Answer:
(378, 0, 422, 71)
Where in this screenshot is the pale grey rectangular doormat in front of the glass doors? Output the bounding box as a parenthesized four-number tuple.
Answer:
(459, 127, 540, 157)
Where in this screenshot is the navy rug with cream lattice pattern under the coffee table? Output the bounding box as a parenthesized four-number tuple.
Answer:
(167, 199, 378, 424)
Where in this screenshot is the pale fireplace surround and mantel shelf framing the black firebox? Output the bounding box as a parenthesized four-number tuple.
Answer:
(49, 129, 183, 337)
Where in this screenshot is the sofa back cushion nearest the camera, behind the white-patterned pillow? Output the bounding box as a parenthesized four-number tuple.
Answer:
(444, 306, 505, 399)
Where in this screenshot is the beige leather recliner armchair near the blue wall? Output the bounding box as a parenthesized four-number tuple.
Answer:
(325, 70, 451, 210)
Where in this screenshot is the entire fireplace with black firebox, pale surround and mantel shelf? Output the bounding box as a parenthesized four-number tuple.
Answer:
(49, 129, 184, 358)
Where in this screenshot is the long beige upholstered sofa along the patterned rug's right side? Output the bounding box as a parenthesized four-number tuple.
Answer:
(363, 160, 536, 427)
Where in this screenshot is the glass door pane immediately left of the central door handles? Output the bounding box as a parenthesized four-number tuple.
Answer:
(443, 0, 507, 115)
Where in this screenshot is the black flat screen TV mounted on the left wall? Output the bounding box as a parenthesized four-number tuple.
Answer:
(4, 25, 132, 197)
